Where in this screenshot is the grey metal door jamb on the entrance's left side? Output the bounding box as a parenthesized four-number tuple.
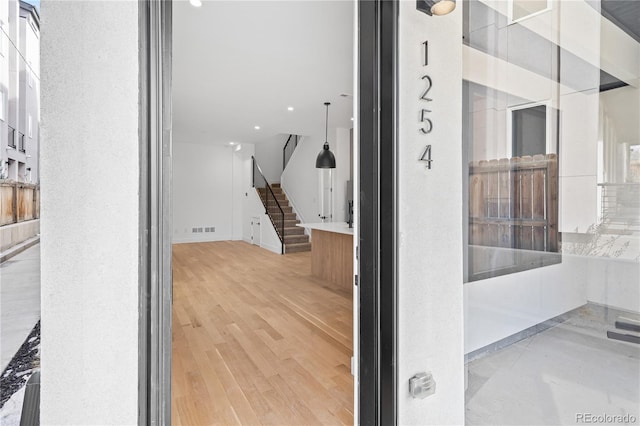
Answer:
(138, 0, 172, 425)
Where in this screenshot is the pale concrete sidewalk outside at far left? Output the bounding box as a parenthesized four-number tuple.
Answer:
(0, 244, 40, 371)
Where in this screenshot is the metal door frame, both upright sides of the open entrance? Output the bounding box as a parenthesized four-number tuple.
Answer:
(138, 0, 399, 426)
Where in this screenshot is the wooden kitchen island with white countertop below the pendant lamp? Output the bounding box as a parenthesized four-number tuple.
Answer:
(298, 222, 353, 291)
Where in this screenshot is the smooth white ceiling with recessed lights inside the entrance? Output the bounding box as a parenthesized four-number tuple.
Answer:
(172, 0, 354, 144)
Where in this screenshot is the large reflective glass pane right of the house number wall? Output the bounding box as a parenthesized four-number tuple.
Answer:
(462, 0, 640, 425)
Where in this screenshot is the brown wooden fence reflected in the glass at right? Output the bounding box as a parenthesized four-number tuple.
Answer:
(469, 154, 558, 252)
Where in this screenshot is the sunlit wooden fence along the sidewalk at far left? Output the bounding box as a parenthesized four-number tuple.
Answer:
(0, 180, 40, 226)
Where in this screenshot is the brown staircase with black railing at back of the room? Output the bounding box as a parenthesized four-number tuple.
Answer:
(256, 183, 311, 253)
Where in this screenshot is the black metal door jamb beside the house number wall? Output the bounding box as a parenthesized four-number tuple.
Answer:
(356, 0, 398, 425)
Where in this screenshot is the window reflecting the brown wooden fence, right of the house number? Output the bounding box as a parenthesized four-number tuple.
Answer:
(463, 82, 561, 282)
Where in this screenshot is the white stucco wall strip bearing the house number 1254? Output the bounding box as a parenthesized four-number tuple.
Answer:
(398, 2, 464, 425)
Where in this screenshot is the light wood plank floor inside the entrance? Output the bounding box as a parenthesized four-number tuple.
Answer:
(172, 241, 353, 425)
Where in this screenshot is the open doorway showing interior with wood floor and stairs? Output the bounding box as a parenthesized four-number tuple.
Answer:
(171, 1, 354, 424)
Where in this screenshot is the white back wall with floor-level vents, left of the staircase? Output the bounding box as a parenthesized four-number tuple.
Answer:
(173, 142, 242, 243)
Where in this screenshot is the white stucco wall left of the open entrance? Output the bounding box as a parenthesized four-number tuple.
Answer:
(40, 1, 140, 425)
